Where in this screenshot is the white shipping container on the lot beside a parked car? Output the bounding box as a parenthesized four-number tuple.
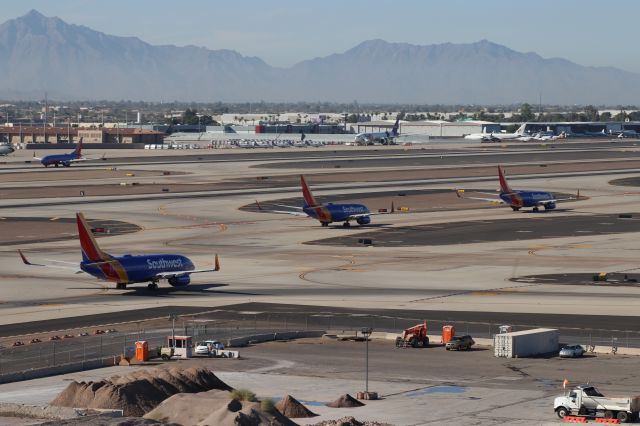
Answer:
(493, 328, 560, 358)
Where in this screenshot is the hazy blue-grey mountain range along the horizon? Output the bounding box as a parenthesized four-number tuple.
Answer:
(0, 10, 640, 105)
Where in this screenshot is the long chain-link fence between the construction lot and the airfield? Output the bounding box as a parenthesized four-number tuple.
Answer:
(0, 311, 640, 376)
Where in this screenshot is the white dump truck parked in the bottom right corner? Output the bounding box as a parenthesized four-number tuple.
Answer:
(553, 386, 640, 423)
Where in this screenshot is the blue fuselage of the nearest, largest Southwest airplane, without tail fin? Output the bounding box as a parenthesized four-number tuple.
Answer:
(80, 254, 195, 286)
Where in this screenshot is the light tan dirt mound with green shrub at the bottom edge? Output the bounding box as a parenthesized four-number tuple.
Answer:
(144, 390, 295, 426)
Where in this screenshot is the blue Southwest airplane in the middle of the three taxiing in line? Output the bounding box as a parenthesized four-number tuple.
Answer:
(256, 175, 376, 228)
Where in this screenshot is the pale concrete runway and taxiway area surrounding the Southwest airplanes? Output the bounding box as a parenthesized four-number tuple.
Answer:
(0, 141, 640, 328)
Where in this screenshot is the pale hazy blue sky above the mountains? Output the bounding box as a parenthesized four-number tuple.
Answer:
(0, 0, 640, 73)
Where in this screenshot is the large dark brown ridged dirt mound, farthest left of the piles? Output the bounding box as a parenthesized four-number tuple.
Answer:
(51, 368, 231, 417)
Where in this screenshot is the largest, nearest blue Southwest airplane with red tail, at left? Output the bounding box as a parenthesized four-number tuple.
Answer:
(18, 213, 220, 290)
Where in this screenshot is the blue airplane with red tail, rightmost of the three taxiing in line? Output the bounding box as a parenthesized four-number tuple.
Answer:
(456, 166, 580, 212)
